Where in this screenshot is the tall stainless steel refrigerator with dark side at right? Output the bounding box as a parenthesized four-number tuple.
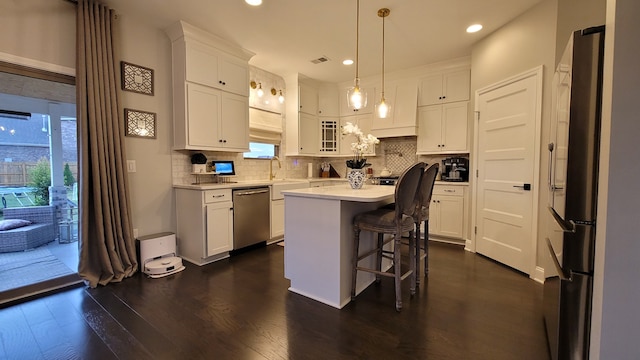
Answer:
(544, 26, 604, 360)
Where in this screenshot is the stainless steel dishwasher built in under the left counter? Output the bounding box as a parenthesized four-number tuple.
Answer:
(233, 187, 271, 250)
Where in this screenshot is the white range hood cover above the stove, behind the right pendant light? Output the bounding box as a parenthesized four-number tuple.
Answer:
(371, 79, 418, 138)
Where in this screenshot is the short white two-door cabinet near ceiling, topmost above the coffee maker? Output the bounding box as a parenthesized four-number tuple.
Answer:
(418, 69, 471, 106)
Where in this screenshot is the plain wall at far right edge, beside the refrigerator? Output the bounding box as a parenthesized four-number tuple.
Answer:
(591, 0, 640, 360)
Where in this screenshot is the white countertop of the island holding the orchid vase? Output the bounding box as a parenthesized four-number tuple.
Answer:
(282, 184, 396, 202)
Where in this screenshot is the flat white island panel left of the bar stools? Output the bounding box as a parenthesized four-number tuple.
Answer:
(284, 195, 342, 308)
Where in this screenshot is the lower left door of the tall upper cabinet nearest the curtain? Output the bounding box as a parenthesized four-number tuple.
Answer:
(187, 84, 221, 147)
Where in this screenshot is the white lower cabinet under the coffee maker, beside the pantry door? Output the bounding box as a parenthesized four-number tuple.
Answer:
(429, 184, 467, 239)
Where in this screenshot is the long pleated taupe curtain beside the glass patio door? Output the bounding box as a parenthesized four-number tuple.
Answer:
(76, 0, 138, 287)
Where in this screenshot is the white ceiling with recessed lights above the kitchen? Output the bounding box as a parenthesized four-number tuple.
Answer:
(104, 0, 541, 82)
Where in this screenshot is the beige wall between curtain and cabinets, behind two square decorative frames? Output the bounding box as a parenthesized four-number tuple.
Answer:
(116, 13, 176, 236)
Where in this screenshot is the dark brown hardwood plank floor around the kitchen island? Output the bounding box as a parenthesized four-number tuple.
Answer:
(0, 243, 548, 360)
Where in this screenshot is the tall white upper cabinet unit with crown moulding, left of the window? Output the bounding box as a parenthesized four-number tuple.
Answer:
(166, 21, 253, 152)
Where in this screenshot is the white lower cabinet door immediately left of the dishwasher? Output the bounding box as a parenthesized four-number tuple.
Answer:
(206, 202, 233, 257)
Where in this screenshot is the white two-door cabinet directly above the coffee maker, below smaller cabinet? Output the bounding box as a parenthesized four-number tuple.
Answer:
(417, 101, 469, 154)
